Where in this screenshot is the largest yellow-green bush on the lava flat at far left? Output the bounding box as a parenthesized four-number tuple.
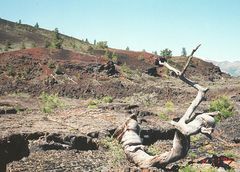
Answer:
(39, 92, 64, 113)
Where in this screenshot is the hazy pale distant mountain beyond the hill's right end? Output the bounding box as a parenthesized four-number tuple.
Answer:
(210, 61, 240, 76)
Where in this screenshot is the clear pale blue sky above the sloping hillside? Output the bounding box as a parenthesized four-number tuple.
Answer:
(0, 0, 240, 61)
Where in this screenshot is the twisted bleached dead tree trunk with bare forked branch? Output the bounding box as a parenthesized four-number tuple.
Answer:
(113, 45, 218, 168)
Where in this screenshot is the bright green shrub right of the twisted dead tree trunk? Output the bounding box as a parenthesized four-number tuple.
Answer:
(209, 96, 233, 122)
